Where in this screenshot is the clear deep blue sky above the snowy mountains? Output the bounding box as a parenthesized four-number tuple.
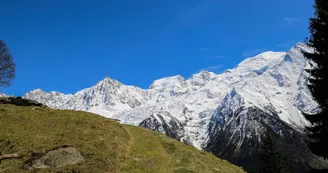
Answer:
(0, 0, 313, 95)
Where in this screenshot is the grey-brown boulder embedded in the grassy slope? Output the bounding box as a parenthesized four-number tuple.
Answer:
(24, 147, 84, 170)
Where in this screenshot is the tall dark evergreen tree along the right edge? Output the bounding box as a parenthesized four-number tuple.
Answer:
(303, 0, 328, 159)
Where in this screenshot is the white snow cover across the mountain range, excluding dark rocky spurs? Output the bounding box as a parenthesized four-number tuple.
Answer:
(24, 43, 317, 148)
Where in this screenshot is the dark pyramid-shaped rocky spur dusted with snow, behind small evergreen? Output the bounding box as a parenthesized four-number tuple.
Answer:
(204, 90, 314, 173)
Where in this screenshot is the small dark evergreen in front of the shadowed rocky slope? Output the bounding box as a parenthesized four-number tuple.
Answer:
(259, 127, 290, 173)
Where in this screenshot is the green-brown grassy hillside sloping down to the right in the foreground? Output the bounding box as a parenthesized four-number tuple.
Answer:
(0, 105, 244, 173)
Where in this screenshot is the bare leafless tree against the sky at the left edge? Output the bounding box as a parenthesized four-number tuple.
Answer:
(0, 40, 16, 87)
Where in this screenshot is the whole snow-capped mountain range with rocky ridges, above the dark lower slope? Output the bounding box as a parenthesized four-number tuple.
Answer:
(24, 43, 317, 172)
